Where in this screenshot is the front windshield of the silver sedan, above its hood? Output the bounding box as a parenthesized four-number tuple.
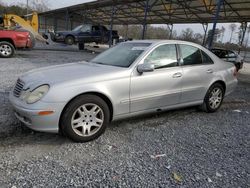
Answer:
(91, 42, 151, 67)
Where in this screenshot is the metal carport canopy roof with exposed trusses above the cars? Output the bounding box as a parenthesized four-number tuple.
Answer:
(39, 0, 250, 25)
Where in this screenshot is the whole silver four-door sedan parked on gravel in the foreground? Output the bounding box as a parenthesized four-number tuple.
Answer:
(9, 40, 237, 142)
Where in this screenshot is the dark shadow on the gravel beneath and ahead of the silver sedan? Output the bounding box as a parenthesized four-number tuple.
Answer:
(0, 107, 197, 147)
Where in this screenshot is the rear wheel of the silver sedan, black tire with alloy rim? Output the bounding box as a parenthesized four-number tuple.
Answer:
(201, 83, 225, 113)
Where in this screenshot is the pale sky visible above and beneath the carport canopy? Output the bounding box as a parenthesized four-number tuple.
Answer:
(3, 0, 245, 43)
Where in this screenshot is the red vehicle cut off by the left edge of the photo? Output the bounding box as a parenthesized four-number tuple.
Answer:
(0, 30, 33, 58)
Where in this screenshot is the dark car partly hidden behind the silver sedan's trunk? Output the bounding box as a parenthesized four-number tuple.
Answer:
(211, 48, 243, 71)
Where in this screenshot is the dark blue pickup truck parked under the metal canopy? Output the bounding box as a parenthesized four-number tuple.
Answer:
(51, 24, 119, 45)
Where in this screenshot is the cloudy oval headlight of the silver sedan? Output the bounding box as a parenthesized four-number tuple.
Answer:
(25, 85, 49, 104)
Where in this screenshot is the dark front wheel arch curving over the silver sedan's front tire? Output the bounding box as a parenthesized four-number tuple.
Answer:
(59, 91, 114, 130)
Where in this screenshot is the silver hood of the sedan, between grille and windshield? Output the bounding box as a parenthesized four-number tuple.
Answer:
(20, 62, 127, 90)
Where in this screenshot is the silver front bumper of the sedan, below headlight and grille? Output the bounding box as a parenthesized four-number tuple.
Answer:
(9, 92, 65, 133)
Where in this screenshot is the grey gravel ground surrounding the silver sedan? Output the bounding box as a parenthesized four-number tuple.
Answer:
(0, 47, 250, 188)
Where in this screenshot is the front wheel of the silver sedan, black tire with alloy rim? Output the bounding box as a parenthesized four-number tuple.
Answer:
(60, 95, 110, 142)
